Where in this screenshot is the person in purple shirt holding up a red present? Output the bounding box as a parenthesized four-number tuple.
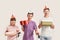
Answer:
(21, 13, 38, 40)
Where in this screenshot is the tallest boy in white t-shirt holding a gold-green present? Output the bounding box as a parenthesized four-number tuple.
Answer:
(38, 6, 54, 40)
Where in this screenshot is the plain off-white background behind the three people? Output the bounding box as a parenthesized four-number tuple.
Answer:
(0, 0, 60, 40)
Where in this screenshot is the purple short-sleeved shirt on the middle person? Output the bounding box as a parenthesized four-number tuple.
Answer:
(23, 21, 37, 40)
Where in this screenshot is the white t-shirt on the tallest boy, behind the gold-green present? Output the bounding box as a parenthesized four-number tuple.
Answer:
(41, 17, 53, 36)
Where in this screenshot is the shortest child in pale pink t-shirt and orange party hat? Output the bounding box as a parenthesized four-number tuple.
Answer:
(5, 15, 19, 40)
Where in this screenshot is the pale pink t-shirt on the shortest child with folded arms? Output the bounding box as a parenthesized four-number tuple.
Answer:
(6, 26, 19, 40)
